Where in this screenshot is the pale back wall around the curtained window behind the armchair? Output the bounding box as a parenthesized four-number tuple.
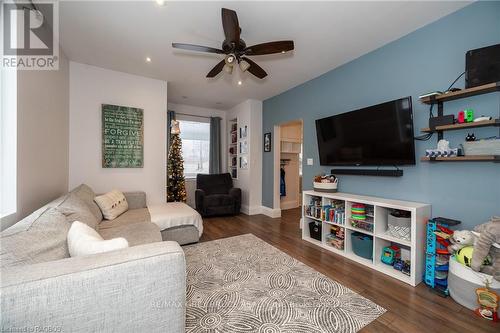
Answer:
(168, 103, 227, 207)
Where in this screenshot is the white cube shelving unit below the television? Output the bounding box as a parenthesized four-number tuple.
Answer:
(301, 191, 431, 286)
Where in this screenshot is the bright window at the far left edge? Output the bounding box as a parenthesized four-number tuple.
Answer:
(0, 69, 17, 217)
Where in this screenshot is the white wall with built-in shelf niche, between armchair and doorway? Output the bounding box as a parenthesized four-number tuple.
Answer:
(227, 100, 263, 215)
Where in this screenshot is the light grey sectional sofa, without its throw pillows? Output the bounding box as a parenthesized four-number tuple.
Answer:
(0, 185, 192, 332)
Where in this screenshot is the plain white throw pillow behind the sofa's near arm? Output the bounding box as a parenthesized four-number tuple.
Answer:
(68, 221, 128, 257)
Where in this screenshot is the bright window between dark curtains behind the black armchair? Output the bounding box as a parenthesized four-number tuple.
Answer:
(178, 119, 210, 178)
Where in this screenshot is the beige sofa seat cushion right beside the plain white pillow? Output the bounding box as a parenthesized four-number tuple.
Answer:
(99, 222, 162, 246)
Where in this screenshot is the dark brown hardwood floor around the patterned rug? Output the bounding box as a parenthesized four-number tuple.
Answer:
(201, 208, 500, 333)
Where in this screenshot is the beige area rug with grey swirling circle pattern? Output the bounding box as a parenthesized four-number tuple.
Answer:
(184, 234, 385, 333)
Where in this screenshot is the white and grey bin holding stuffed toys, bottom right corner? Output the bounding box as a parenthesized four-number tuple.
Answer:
(448, 256, 500, 310)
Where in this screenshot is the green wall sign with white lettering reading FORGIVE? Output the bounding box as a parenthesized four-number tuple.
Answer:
(102, 104, 144, 168)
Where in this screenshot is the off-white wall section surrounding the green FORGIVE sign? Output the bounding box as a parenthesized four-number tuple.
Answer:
(69, 62, 167, 204)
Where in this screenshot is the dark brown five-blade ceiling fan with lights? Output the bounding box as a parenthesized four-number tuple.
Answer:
(172, 8, 294, 79)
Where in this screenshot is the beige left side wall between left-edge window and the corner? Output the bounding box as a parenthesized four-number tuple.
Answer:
(1, 50, 69, 230)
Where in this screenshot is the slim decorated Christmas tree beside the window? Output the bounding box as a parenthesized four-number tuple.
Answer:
(167, 120, 186, 202)
